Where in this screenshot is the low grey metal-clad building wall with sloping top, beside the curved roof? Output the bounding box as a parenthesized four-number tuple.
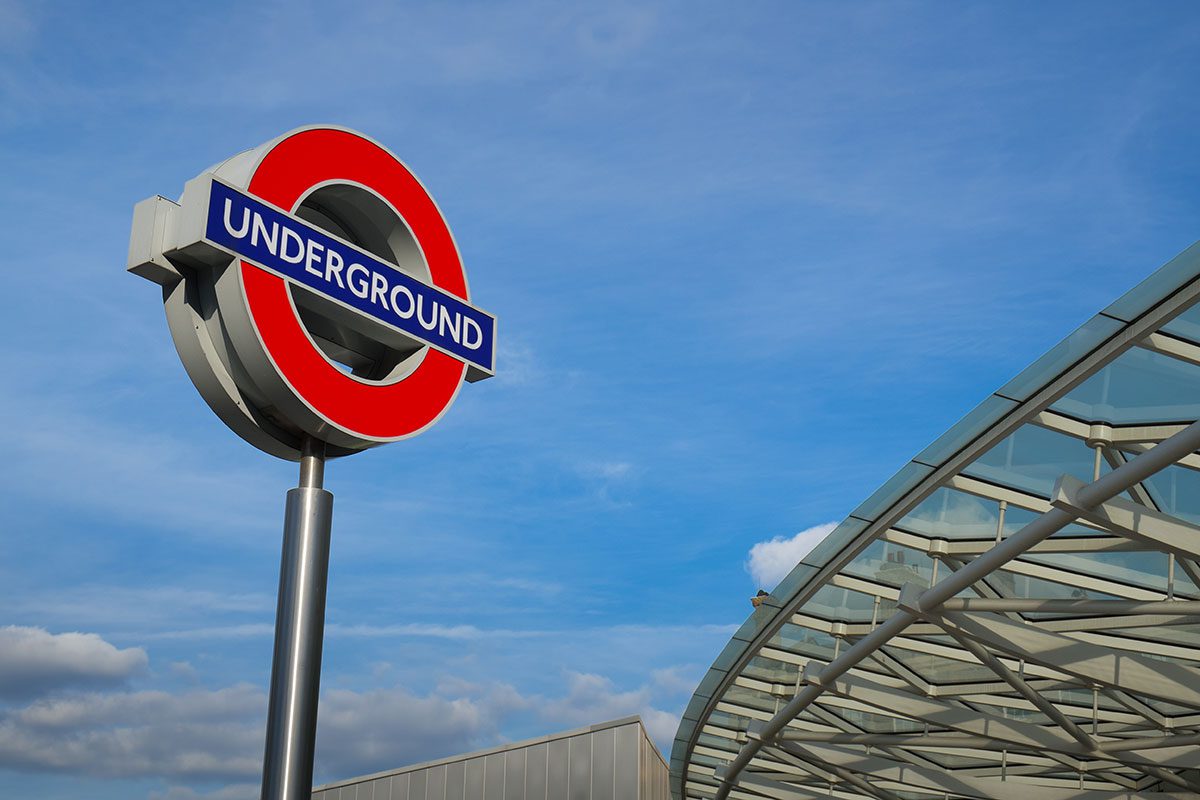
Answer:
(313, 718, 670, 800)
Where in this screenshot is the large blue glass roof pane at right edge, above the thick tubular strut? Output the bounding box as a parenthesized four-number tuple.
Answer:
(1050, 348, 1200, 425)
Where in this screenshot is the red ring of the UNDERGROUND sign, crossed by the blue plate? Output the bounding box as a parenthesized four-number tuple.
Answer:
(240, 128, 469, 441)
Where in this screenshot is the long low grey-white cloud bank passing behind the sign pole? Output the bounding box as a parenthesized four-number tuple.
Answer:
(0, 668, 690, 786)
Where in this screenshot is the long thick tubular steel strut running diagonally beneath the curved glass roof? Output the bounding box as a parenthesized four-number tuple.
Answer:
(715, 421, 1200, 800)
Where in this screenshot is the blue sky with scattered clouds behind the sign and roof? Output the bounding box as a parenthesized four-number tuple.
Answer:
(0, 0, 1200, 800)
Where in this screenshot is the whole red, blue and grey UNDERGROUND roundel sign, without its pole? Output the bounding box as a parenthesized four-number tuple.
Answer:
(128, 127, 496, 459)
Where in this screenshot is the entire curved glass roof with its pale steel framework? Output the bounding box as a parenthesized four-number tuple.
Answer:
(671, 243, 1200, 800)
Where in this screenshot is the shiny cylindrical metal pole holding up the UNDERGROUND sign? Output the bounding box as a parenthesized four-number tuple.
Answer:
(263, 438, 334, 800)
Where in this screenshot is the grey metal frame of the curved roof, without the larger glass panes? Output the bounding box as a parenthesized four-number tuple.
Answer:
(672, 247, 1200, 800)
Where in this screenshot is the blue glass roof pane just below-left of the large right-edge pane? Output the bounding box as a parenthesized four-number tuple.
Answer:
(962, 425, 1108, 498)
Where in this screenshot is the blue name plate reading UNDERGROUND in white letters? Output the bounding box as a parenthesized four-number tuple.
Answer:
(204, 180, 496, 374)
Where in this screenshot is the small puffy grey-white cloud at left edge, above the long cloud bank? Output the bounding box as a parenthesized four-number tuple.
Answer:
(0, 625, 146, 699)
